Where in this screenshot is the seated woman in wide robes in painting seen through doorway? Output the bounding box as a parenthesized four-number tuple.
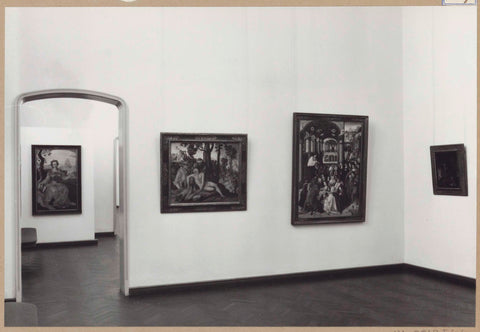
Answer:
(37, 160, 76, 210)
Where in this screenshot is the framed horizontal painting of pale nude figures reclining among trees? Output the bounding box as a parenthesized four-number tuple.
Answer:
(160, 133, 247, 213)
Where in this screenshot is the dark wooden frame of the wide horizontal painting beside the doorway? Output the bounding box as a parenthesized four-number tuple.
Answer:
(160, 133, 248, 213)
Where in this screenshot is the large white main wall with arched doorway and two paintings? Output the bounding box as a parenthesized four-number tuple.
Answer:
(5, 7, 474, 296)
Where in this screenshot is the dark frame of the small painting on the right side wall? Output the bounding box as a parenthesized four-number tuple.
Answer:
(430, 144, 468, 196)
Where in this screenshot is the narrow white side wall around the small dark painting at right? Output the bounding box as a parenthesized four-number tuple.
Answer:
(403, 7, 477, 278)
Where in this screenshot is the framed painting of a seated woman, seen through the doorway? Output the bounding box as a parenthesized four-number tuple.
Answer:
(32, 145, 82, 216)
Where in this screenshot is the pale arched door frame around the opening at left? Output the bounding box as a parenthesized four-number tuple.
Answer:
(13, 89, 129, 302)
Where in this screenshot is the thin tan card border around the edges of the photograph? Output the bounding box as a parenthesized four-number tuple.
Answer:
(0, 0, 480, 332)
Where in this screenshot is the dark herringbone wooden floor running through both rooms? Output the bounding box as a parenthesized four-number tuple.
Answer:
(15, 238, 475, 327)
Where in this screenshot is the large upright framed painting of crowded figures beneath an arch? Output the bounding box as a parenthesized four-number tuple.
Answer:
(292, 113, 368, 225)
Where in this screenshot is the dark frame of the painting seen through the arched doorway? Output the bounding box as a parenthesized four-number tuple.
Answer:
(32, 145, 82, 216)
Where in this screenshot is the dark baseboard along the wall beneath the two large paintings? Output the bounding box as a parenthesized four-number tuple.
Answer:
(129, 264, 403, 296)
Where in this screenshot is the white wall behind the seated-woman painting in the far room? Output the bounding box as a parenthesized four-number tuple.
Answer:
(20, 127, 95, 243)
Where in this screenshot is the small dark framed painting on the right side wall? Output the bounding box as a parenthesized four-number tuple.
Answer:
(430, 144, 468, 196)
